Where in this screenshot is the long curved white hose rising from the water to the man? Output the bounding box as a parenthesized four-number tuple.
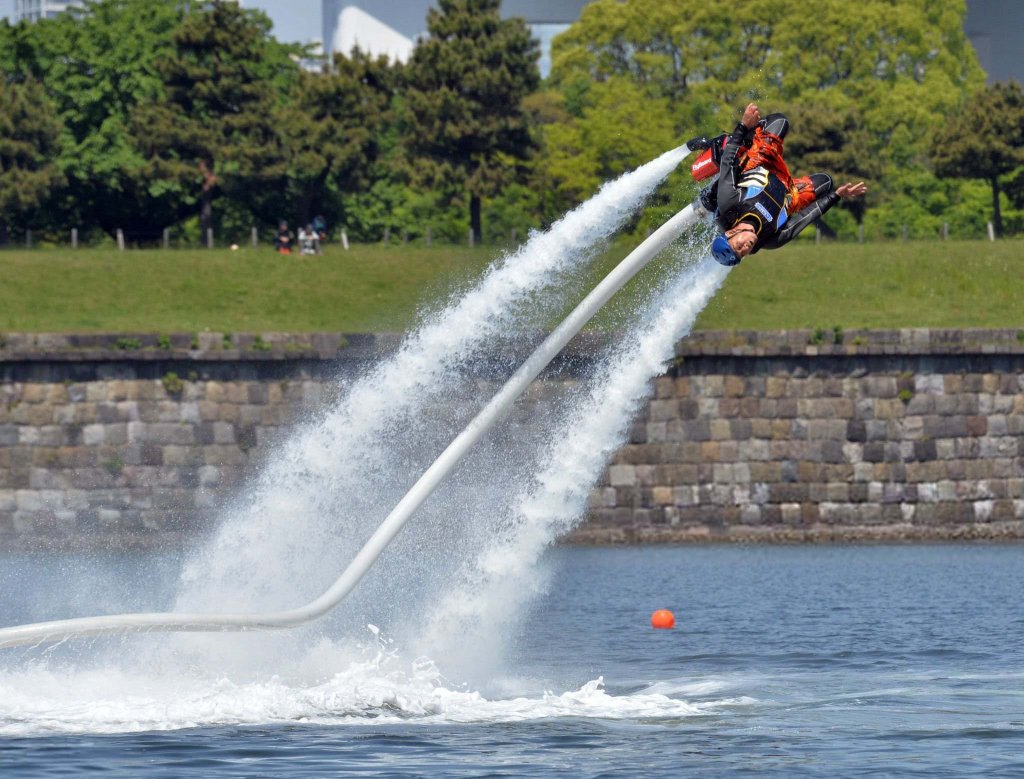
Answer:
(0, 149, 708, 648)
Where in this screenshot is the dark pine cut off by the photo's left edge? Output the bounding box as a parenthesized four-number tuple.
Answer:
(0, 80, 62, 238)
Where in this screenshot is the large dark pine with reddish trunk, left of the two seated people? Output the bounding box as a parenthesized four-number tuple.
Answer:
(134, 0, 298, 240)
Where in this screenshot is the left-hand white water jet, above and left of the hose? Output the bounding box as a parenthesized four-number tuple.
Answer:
(176, 147, 687, 610)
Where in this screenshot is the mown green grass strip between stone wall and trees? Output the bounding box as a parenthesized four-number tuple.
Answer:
(0, 241, 1024, 333)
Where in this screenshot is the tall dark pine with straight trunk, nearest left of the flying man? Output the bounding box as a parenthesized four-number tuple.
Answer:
(406, 0, 540, 239)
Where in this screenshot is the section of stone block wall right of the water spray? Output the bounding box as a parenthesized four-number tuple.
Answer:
(575, 330, 1024, 542)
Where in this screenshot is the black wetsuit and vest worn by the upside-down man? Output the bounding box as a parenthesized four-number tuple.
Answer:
(700, 114, 840, 254)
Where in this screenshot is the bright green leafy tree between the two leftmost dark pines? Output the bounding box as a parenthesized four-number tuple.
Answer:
(0, 0, 183, 236)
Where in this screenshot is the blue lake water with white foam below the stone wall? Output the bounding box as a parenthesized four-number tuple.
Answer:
(0, 546, 1024, 777)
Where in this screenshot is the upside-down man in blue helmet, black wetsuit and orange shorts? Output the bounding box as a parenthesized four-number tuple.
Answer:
(687, 102, 867, 265)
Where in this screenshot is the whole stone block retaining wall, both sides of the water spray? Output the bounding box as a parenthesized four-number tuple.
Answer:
(0, 330, 1024, 548)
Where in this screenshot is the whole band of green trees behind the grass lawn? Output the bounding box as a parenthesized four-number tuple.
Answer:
(0, 0, 1024, 242)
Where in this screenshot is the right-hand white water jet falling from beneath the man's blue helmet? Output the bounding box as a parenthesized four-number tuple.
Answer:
(418, 242, 728, 675)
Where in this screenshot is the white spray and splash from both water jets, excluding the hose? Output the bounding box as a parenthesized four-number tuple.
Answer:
(0, 149, 727, 733)
